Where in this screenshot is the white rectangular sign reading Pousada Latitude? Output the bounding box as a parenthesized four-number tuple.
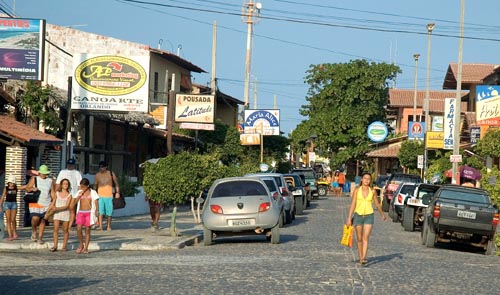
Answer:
(175, 94, 215, 124)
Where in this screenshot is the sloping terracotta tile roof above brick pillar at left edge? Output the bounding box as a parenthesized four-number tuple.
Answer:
(0, 115, 64, 146)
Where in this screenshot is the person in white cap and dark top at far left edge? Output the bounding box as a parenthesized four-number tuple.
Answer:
(0, 175, 18, 241)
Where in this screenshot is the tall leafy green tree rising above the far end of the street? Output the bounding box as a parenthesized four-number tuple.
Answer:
(292, 60, 400, 166)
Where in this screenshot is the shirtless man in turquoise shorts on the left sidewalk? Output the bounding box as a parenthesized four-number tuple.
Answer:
(94, 161, 120, 230)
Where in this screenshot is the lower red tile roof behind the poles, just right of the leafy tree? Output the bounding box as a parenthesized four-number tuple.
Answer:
(388, 89, 469, 112)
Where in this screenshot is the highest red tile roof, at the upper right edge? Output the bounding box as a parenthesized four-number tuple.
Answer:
(443, 63, 500, 89)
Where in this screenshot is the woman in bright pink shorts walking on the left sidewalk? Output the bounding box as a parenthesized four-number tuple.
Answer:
(76, 178, 99, 254)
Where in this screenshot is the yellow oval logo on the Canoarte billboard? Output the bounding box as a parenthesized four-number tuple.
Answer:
(74, 55, 147, 96)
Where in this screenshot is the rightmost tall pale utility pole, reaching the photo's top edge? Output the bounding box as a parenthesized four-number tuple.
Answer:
(452, 0, 465, 184)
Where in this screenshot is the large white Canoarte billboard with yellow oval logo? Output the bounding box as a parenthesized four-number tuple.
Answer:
(71, 54, 149, 113)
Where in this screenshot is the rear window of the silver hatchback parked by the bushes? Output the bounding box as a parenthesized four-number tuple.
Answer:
(212, 181, 267, 198)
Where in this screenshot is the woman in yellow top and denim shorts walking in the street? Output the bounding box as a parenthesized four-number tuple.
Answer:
(346, 172, 386, 265)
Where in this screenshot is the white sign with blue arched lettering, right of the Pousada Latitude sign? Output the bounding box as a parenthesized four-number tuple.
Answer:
(244, 110, 280, 135)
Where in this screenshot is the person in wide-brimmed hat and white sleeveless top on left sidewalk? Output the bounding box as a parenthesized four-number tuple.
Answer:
(26, 165, 55, 244)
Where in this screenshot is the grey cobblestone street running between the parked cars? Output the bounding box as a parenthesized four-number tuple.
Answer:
(0, 196, 500, 294)
